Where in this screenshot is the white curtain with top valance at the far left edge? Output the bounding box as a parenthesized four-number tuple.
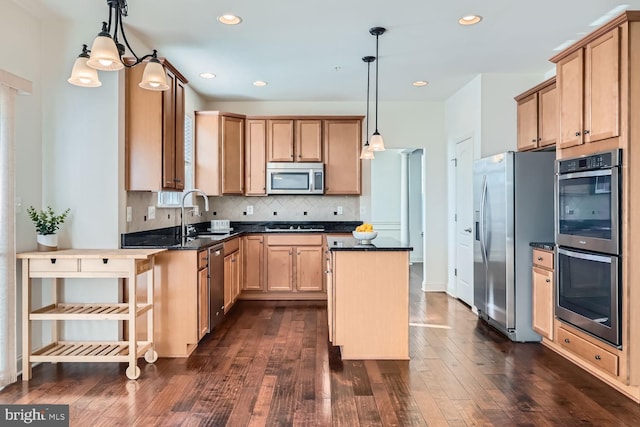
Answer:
(0, 70, 31, 389)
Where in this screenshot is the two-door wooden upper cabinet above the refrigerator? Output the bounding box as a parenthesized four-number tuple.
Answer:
(515, 77, 558, 151)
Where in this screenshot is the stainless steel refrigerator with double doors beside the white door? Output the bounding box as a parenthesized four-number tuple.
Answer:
(473, 151, 555, 342)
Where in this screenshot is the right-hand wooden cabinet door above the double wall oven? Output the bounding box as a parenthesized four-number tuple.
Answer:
(583, 28, 620, 142)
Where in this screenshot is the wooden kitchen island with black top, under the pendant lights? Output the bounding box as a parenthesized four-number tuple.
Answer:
(327, 237, 413, 360)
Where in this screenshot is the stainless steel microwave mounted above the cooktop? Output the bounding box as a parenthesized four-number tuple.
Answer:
(267, 162, 324, 194)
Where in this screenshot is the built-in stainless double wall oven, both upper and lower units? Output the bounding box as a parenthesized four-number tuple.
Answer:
(555, 150, 622, 346)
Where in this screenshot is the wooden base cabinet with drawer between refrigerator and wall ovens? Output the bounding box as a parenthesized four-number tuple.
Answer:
(532, 248, 555, 340)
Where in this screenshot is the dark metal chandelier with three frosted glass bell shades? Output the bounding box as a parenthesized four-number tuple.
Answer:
(67, 0, 169, 91)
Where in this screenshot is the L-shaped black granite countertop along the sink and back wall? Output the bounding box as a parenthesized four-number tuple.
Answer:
(120, 221, 362, 250)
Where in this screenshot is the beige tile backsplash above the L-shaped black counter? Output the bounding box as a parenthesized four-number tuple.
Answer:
(126, 191, 360, 233)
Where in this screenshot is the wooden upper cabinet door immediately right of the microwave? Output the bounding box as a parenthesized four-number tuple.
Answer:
(323, 120, 362, 195)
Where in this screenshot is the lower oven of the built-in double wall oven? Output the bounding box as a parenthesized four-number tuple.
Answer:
(556, 247, 621, 346)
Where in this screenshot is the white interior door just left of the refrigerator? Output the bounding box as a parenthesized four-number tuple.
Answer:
(455, 138, 473, 306)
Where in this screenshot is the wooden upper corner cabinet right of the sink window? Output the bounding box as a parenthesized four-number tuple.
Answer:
(195, 111, 245, 196)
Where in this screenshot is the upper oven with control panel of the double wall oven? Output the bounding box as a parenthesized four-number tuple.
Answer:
(555, 150, 621, 254)
